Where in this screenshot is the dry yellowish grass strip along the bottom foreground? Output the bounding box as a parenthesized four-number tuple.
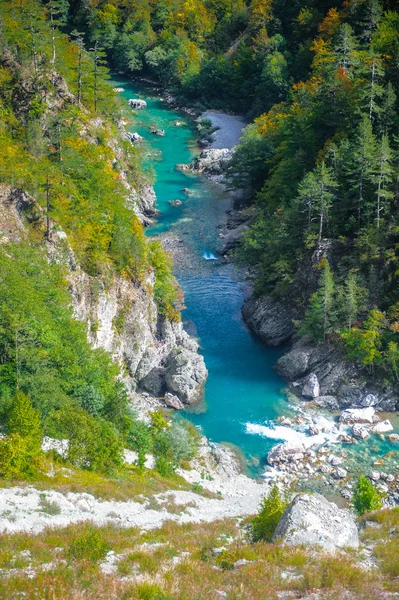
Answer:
(0, 510, 399, 600)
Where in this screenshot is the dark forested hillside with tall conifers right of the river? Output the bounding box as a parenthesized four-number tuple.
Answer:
(62, 0, 399, 380)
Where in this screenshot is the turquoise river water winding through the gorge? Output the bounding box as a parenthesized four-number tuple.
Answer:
(112, 79, 398, 487)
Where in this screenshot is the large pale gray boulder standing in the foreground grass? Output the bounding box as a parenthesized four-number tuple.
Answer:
(273, 494, 359, 552)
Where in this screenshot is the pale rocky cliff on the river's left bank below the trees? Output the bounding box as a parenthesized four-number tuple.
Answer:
(70, 269, 207, 404)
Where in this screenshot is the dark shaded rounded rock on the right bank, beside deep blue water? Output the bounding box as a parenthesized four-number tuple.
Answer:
(242, 296, 295, 346)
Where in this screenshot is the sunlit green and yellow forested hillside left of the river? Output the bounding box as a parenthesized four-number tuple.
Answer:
(0, 0, 200, 479)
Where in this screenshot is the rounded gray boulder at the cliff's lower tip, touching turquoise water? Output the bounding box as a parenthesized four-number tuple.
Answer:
(165, 347, 208, 404)
